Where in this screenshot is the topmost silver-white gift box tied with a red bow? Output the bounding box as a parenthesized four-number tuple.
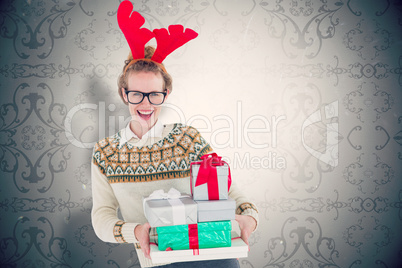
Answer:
(190, 154, 231, 200)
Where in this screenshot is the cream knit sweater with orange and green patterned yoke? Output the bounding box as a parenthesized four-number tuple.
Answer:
(91, 124, 258, 267)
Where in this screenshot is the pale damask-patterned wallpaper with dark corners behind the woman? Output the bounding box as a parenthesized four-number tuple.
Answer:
(0, 0, 402, 268)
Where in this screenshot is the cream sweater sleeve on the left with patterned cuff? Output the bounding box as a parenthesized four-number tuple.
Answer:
(91, 161, 138, 243)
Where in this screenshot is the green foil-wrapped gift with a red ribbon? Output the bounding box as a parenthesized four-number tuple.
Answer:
(156, 221, 232, 251)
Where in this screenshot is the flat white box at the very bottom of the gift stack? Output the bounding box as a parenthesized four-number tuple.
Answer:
(150, 232, 249, 264)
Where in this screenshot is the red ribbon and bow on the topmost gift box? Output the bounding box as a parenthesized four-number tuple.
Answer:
(195, 153, 232, 200)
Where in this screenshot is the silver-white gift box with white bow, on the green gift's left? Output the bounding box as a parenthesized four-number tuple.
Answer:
(143, 190, 197, 227)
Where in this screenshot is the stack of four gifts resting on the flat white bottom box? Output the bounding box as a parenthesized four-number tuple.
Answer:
(144, 154, 236, 251)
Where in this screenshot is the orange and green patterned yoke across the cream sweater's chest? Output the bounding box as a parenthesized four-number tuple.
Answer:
(93, 124, 211, 183)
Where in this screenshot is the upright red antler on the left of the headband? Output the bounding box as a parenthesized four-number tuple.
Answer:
(117, 0, 154, 59)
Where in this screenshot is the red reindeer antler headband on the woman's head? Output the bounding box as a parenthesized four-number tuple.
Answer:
(117, 0, 198, 73)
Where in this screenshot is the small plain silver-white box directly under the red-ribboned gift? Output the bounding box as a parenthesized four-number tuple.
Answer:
(195, 197, 236, 222)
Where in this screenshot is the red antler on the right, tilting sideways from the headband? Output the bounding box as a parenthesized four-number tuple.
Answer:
(152, 25, 198, 63)
